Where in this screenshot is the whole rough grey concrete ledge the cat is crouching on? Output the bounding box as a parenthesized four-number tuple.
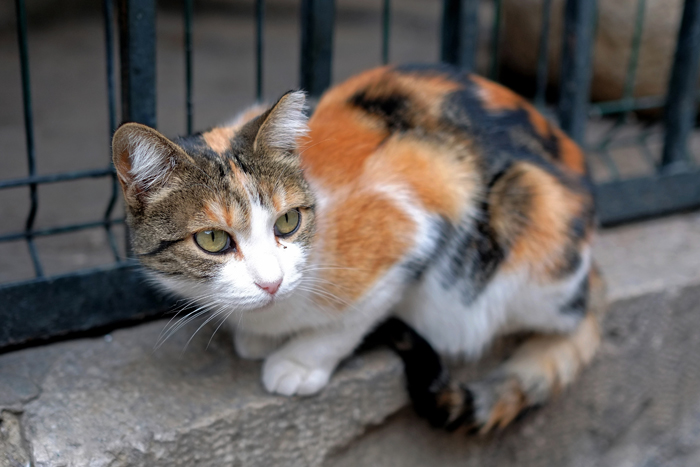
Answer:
(0, 214, 700, 467)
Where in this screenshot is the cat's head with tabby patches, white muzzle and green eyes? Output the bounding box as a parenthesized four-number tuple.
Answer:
(112, 92, 315, 310)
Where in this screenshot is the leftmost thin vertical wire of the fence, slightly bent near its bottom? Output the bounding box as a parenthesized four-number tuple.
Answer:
(15, 0, 44, 277)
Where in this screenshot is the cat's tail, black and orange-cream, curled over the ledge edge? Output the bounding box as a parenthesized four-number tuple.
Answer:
(366, 267, 606, 433)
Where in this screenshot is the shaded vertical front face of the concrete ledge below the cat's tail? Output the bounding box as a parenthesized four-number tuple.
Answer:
(325, 287, 700, 467)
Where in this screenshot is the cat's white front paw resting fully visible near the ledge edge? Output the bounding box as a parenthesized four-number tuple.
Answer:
(263, 355, 332, 396)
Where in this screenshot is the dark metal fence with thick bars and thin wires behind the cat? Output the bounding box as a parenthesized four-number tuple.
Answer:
(0, 0, 700, 349)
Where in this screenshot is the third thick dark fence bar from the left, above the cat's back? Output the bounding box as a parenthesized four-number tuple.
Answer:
(440, 0, 479, 71)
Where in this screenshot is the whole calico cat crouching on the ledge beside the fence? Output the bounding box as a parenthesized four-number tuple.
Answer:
(113, 66, 600, 431)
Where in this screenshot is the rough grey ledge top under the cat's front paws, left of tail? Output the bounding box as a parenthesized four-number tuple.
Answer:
(0, 328, 406, 467)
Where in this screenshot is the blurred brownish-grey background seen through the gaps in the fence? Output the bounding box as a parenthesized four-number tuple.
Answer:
(0, 0, 700, 283)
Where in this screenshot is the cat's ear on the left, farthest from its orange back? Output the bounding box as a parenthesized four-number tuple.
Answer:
(112, 123, 181, 195)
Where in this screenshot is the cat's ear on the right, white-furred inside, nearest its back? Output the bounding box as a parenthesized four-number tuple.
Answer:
(253, 91, 309, 153)
